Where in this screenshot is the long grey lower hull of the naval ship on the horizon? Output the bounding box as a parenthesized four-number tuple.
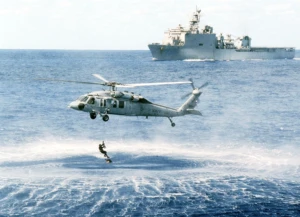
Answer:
(148, 44, 295, 60)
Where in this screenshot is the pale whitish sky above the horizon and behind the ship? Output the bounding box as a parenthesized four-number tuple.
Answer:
(0, 0, 300, 50)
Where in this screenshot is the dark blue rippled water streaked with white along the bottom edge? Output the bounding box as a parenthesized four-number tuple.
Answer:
(0, 173, 299, 216)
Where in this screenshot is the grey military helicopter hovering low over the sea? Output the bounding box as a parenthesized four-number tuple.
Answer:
(39, 74, 208, 127)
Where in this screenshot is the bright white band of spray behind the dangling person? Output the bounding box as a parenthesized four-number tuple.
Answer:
(0, 138, 300, 166)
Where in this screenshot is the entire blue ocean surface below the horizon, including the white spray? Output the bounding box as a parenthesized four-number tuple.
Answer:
(0, 50, 300, 216)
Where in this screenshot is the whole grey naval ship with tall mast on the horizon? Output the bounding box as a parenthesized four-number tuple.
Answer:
(148, 9, 295, 60)
